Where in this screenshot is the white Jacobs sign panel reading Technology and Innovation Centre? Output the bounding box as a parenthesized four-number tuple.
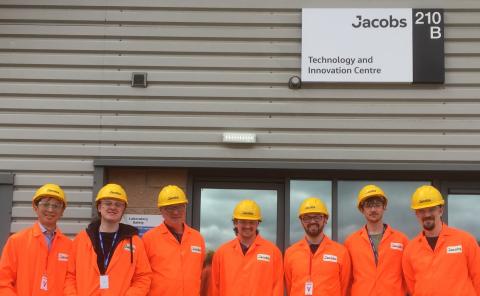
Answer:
(302, 8, 413, 83)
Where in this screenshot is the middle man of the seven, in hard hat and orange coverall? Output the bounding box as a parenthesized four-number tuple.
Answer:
(209, 200, 283, 296)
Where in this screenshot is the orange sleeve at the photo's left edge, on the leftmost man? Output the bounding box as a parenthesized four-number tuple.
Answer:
(0, 237, 17, 296)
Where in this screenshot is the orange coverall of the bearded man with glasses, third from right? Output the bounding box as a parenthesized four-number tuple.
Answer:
(284, 236, 351, 296)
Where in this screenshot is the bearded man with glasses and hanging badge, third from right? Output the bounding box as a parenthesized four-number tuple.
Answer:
(284, 197, 351, 296)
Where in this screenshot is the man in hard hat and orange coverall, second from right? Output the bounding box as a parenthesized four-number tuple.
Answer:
(345, 185, 408, 296)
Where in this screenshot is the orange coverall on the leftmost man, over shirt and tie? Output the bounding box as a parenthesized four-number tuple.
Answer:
(0, 222, 72, 296)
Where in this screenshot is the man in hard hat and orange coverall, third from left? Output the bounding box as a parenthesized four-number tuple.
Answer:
(143, 185, 205, 296)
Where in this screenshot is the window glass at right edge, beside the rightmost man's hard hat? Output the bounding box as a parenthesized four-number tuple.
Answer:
(448, 194, 480, 243)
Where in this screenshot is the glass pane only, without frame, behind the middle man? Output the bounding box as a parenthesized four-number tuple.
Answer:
(200, 188, 277, 250)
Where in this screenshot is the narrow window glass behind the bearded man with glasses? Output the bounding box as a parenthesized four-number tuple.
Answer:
(290, 180, 332, 245)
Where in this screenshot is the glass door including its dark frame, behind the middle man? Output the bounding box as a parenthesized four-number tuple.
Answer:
(193, 182, 284, 250)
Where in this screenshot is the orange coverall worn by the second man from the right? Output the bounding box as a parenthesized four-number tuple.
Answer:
(345, 225, 408, 296)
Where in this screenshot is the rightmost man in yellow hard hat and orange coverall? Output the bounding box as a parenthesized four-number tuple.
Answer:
(403, 186, 480, 296)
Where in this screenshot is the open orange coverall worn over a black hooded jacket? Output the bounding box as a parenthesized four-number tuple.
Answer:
(64, 230, 151, 296)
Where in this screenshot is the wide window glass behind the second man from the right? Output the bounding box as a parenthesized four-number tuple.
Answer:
(338, 181, 430, 242)
